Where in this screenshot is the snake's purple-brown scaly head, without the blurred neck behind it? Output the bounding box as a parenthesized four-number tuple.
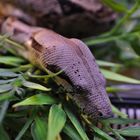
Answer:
(34, 30, 112, 119)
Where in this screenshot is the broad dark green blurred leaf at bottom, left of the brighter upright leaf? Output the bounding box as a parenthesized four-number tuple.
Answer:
(31, 117, 47, 140)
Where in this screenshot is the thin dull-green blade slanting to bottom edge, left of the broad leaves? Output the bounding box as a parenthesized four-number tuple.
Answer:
(15, 119, 33, 140)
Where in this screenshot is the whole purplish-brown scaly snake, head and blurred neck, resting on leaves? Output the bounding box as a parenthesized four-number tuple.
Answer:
(2, 18, 112, 119)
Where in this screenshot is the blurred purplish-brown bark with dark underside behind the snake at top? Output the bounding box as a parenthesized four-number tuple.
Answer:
(1, 0, 116, 38)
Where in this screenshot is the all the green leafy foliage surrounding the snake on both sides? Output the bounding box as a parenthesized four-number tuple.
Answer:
(0, 0, 140, 140)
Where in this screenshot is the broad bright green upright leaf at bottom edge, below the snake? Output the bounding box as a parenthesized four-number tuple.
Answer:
(47, 105, 66, 140)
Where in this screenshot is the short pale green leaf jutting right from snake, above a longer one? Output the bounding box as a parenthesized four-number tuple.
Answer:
(96, 60, 122, 67)
